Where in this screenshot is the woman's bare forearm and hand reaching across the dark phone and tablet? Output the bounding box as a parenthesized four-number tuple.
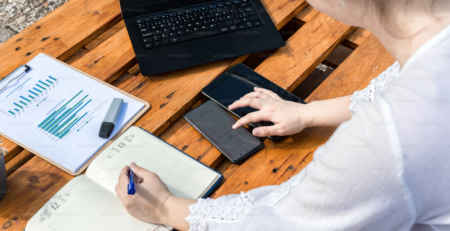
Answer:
(229, 88, 352, 137)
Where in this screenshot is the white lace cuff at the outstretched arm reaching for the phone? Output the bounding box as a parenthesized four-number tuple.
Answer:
(349, 62, 400, 112)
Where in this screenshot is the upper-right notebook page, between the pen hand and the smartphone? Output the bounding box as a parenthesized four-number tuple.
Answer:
(86, 127, 220, 199)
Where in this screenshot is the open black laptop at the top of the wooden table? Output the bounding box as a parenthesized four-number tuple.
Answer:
(120, 0, 285, 76)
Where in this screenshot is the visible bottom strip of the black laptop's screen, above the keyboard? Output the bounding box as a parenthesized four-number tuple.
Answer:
(120, 0, 221, 18)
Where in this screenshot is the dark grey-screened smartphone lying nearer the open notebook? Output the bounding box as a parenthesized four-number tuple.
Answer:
(184, 100, 263, 164)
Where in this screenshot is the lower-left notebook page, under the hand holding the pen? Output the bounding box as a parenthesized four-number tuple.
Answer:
(26, 175, 169, 231)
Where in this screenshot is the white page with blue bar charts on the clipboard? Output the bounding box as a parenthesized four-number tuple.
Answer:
(0, 54, 144, 172)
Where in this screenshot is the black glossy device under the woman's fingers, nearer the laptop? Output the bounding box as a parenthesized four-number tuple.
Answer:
(202, 64, 306, 140)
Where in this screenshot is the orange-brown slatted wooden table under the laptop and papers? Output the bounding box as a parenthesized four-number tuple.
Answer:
(0, 0, 394, 230)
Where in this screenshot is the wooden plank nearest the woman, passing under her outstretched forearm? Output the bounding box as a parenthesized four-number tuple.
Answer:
(213, 33, 395, 197)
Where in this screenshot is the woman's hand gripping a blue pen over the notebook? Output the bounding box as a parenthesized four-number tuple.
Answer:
(116, 163, 196, 230)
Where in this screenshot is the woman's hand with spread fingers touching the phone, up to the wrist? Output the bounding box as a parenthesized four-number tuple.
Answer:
(229, 87, 311, 137)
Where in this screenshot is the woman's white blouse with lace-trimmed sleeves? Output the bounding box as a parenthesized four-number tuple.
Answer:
(186, 24, 450, 231)
